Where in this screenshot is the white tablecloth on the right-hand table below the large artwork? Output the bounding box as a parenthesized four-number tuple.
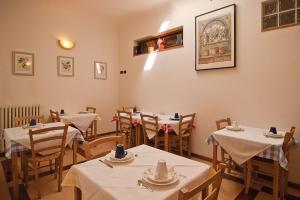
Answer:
(208, 126, 284, 164)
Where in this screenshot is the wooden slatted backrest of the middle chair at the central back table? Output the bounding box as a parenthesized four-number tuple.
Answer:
(140, 113, 159, 142)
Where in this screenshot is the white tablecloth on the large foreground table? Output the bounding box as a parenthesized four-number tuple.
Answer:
(63, 145, 210, 200)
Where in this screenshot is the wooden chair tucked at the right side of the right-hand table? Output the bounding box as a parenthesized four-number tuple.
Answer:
(245, 127, 296, 199)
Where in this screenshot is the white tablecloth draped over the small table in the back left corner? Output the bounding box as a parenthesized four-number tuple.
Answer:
(60, 113, 100, 132)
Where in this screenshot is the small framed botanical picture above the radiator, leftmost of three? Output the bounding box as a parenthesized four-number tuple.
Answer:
(12, 51, 34, 76)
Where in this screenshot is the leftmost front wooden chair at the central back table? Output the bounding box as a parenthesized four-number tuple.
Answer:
(117, 110, 133, 148)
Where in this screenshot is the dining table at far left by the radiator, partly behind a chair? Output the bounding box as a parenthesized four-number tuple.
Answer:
(3, 122, 84, 199)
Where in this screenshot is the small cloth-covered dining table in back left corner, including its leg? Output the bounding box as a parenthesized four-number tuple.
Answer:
(60, 111, 101, 139)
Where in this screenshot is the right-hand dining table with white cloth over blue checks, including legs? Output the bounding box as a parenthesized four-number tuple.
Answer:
(206, 126, 288, 199)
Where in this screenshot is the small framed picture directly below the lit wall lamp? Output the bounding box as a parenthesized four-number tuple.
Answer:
(57, 56, 74, 77)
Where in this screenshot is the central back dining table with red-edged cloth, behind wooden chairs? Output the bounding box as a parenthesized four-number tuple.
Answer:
(112, 111, 188, 151)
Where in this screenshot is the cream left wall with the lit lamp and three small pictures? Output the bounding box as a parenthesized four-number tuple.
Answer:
(0, 0, 119, 132)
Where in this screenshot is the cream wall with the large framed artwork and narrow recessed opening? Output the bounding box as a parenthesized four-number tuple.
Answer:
(120, 0, 300, 183)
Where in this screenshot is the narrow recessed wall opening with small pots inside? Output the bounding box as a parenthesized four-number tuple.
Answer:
(133, 26, 183, 56)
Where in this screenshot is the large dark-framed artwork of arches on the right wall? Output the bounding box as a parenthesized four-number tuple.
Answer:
(195, 4, 236, 70)
